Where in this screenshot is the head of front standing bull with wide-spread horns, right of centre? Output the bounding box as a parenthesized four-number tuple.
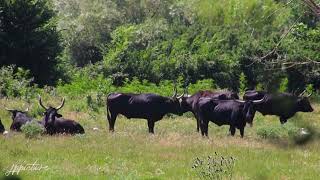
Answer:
(235, 96, 266, 126)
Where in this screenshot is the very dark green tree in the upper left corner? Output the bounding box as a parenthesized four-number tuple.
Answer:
(0, 0, 61, 85)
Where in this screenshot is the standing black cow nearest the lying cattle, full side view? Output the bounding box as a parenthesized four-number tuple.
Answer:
(106, 89, 182, 133)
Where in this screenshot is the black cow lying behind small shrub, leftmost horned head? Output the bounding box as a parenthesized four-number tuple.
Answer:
(6, 108, 32, 132)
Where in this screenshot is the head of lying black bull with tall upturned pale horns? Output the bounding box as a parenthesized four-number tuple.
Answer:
(39, 96, 65, 126)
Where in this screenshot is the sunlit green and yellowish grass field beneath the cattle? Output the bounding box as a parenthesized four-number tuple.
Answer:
(0, 99, 320, 180)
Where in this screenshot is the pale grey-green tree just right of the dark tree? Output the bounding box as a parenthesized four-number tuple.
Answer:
(53, 0, 124, 67)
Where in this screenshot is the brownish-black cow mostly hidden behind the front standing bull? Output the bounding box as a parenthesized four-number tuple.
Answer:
(181, 90, 239, 132)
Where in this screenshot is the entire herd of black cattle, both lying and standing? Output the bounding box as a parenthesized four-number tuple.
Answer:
(0, 87, 313, 137)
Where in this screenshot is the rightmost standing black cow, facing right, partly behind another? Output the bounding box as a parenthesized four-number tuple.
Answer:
(243, 90, 313, 124)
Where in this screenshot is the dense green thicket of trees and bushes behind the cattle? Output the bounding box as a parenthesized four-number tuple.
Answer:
(0, 0, 320, 96)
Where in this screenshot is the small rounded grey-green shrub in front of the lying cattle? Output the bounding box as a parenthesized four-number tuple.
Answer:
(21, 121, 45, 138)
